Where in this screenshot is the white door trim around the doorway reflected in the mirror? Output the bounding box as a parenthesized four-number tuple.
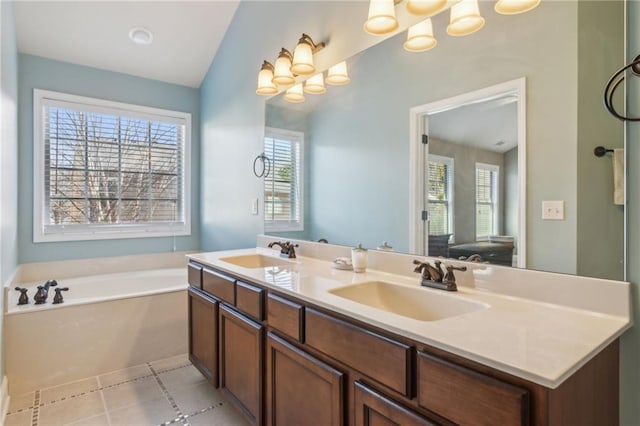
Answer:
(409, 77, 527, 268)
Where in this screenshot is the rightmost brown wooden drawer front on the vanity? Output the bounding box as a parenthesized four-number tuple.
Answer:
(418, 353, 529, 426)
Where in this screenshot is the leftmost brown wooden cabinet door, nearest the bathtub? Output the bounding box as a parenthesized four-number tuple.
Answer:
(188, 288, 218, 387)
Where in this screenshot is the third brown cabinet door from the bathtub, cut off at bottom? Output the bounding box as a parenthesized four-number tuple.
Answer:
(267, 333, 344, 426)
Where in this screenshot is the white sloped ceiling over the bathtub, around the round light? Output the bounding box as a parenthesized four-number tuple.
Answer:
(14, 0, 239, 87)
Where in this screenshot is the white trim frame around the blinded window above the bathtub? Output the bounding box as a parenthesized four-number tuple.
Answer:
(33, 89, 191, 243)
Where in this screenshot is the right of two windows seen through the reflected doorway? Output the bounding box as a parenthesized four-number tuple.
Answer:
(476, 163, 500, 240)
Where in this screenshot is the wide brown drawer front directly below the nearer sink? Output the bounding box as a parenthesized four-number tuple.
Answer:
(305, 308, 413, 398)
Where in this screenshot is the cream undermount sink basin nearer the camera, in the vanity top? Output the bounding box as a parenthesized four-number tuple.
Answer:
(329, 281, 489, 321)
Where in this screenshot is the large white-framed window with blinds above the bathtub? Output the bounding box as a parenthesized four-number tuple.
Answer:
(33, 90, 191, 242)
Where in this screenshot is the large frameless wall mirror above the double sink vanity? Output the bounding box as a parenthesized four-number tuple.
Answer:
(265, 1, 624, 279)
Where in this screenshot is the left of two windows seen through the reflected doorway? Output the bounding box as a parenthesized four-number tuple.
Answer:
(428, 155, 453, 235)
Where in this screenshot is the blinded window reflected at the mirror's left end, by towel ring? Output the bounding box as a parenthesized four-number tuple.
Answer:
(264, 127, 304, 231)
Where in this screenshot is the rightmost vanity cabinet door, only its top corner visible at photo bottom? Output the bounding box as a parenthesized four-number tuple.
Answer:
(353, 382, 435, 426)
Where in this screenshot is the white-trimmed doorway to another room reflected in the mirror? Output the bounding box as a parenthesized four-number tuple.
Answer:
(411, 79, 526, 267)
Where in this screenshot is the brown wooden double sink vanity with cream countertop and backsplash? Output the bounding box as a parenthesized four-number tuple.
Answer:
(188, 236, 631, 425)
